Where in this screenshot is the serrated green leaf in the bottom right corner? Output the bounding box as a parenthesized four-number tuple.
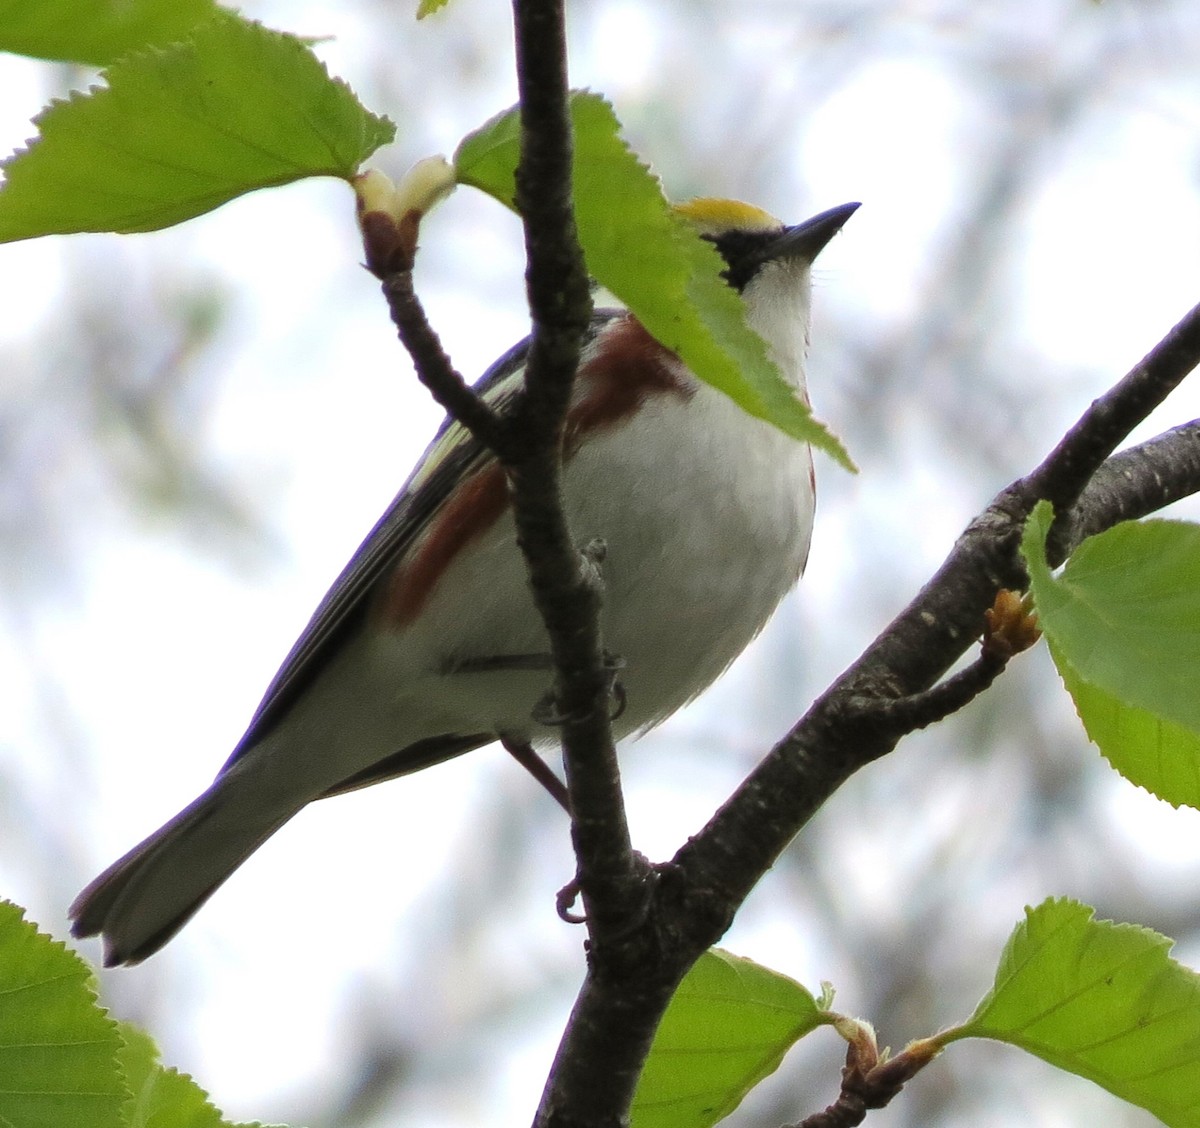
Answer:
(955, 899, 1200, 1128)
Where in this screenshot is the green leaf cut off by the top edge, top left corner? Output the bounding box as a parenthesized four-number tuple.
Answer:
(0, 0, 218, 66)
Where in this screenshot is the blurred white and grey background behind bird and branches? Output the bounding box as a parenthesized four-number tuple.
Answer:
(0, 0, 1200, 1128)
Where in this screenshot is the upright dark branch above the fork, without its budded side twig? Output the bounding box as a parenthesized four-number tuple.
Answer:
(505, 0, 644, 959)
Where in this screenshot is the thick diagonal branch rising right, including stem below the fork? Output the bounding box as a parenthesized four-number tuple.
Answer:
(538, 300, 1200, 1128)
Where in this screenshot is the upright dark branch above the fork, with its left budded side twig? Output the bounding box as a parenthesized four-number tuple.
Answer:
(355, 0, 648, 959)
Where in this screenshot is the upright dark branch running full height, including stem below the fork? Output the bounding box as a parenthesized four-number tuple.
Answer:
(509, 8, 676, 1128)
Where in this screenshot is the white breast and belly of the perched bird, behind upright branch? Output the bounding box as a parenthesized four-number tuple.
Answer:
(393, 386, 814, 739)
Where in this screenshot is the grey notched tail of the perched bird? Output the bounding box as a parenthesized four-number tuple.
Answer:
(71, 775, 299, 967)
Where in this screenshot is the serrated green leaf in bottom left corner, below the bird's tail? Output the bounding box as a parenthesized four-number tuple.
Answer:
(0, 901, 130, 1128)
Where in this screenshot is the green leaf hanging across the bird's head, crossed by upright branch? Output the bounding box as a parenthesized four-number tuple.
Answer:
(454, 91, 853, 469)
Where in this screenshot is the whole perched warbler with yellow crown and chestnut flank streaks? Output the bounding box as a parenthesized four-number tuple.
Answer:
(70, 198, 858, 966)
